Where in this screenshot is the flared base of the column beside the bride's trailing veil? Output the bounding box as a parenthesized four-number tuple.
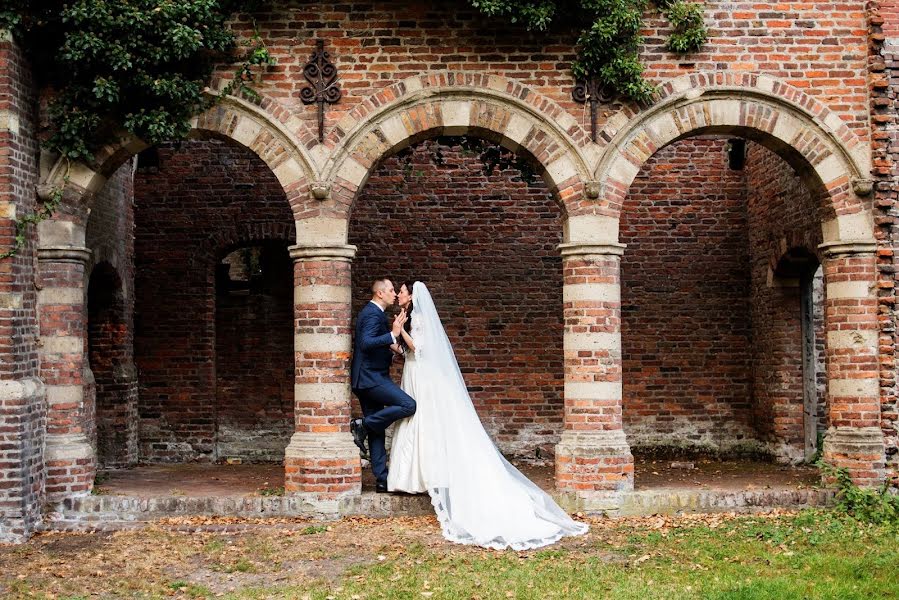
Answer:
(556, 429, 634, 511)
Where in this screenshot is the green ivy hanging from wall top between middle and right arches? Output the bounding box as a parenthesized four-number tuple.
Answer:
(469, 0, 708, 102)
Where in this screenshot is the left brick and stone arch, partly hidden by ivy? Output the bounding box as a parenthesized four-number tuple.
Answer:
(42, 96, 316, 223)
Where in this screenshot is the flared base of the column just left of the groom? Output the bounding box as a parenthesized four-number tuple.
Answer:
(284, 432, 362, 513)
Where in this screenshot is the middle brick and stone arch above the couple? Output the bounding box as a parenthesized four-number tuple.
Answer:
(323, 82, 589, 237)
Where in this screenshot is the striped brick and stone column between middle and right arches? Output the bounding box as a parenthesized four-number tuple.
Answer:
(556, 243, 634, 510)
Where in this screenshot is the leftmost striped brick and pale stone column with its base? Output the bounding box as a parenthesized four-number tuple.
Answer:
(38, 221, 96, 503)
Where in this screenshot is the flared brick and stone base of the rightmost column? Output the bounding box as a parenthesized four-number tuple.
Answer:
(824, 427, 886, 487)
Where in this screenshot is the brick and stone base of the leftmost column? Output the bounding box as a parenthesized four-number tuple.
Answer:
(44, 433, 97, 504)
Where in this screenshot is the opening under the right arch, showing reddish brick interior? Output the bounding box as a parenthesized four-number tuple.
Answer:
(620, 132, 824, 489)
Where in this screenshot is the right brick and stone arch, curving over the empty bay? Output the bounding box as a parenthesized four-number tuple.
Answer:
(596, 73, 873, 242)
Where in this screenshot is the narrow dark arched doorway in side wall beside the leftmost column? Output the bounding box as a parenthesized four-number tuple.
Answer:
(87, 262, 138, 468)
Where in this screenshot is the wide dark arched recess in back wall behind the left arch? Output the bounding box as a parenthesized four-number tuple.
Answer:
(215, 240, 294, 462)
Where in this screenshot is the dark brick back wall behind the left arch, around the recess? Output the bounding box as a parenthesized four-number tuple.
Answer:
(135, 140, 295, 461)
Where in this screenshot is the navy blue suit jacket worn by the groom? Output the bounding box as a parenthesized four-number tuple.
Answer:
(350, 302, 393, 390)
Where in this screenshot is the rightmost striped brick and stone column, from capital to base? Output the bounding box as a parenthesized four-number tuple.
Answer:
(821, 242, 885, 485)
